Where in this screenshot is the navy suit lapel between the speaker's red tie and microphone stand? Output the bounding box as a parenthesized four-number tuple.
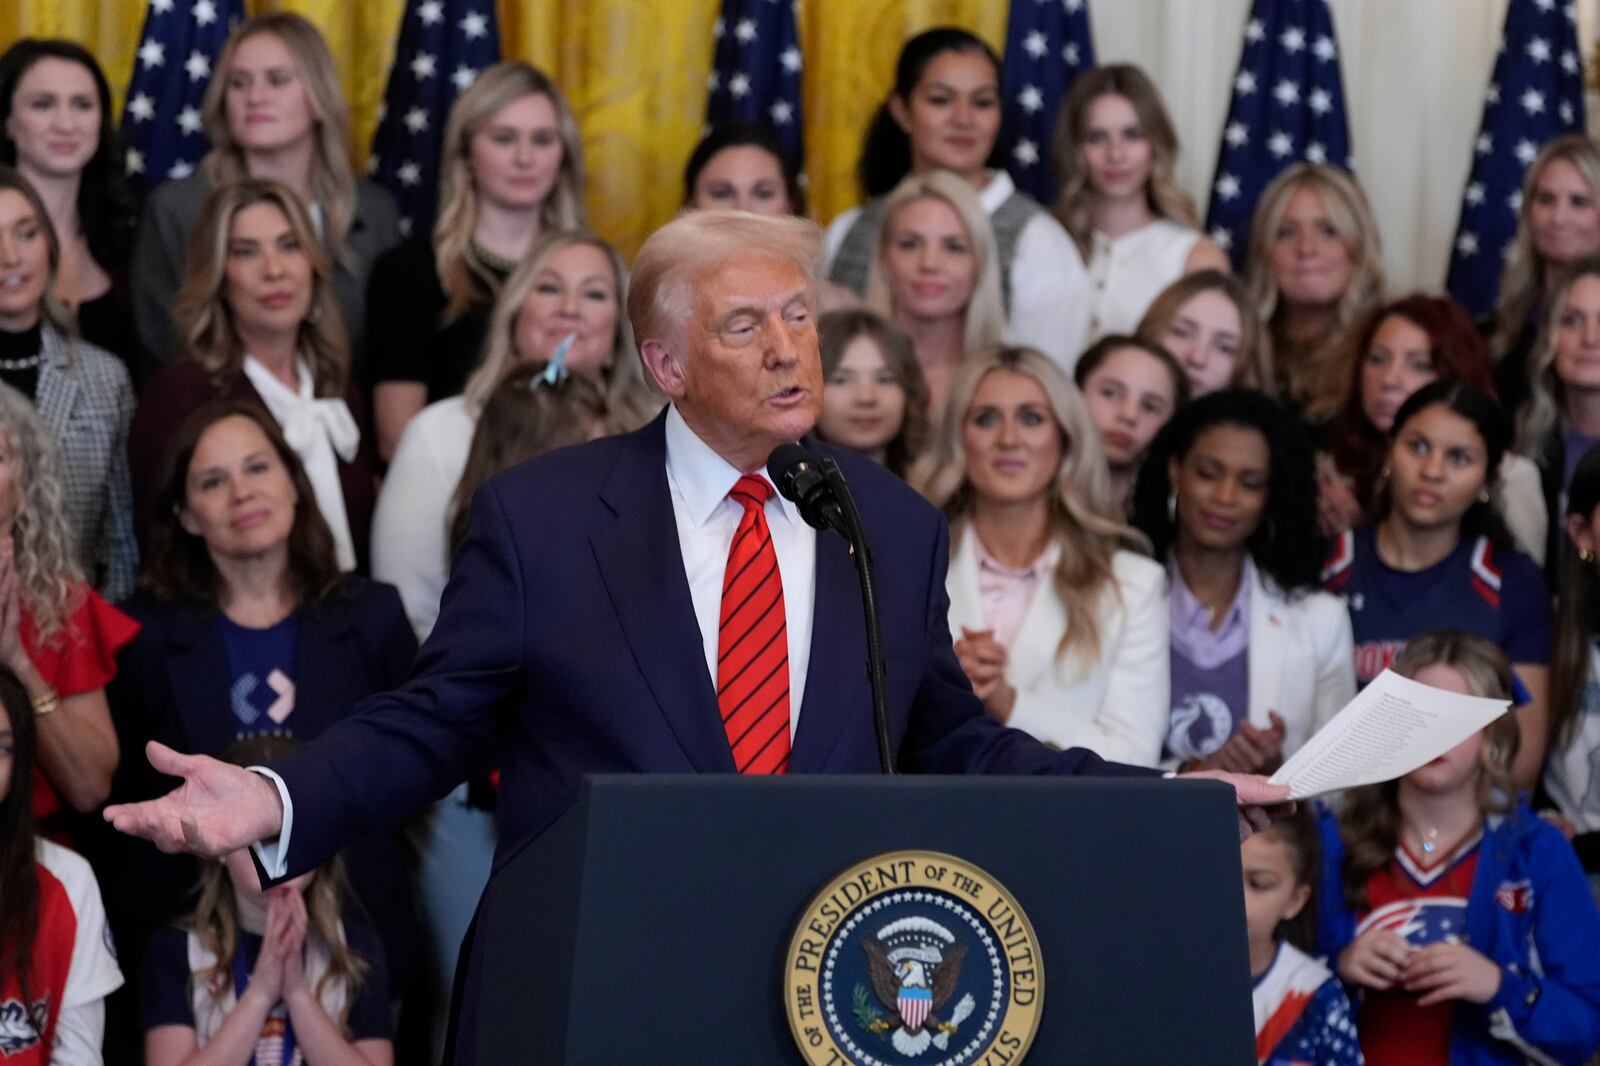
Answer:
(789, 531, 872, 773)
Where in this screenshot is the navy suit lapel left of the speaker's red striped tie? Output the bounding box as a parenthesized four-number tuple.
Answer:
(589, 415, 734, 773)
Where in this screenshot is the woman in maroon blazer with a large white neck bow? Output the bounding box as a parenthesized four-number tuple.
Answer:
(128, 178, 376, 571)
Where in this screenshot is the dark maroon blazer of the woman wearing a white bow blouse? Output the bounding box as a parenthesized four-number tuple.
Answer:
(128, 359, 378, 573)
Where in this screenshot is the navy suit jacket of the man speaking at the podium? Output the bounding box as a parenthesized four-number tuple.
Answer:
(274, 415, 1149, 876)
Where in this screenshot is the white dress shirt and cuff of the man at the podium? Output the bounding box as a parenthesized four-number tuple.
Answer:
(251, 407, 816, 877)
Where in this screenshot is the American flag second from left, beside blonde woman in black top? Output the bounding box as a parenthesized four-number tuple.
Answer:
(366, 0, 499, 237)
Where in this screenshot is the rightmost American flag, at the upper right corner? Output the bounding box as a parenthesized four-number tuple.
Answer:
(1445, 0, 1584, 315)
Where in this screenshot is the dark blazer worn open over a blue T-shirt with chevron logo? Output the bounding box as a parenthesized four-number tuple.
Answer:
(96, 576, 421, 989)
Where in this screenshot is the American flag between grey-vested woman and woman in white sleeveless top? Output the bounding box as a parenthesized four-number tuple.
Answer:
(1000, 0, 1094, 203)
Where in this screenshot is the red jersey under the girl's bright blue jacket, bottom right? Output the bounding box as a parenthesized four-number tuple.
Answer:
(1355, 829, 1483, 1066)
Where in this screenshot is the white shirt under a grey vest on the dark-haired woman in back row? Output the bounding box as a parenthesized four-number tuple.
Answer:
(822, 170, 1090, 364)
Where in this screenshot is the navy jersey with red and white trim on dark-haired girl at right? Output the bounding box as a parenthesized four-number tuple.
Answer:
(1322, 527, 1550, 685)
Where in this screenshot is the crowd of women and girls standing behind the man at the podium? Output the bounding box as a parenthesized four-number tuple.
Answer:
(0, 13, 1600, 1066)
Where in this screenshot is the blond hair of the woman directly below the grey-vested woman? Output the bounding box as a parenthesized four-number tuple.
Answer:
(866, 170, 1005, 355)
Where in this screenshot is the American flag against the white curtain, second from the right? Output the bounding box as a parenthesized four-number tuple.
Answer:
(1206, 0, 1355, 267)
